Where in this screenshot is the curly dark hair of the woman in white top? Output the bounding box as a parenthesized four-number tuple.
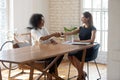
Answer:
(27, 13, 44, 30)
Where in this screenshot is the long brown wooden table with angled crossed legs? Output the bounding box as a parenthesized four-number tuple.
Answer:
(0, 44, 93, 80)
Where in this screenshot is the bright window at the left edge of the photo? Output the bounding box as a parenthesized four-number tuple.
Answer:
(0, 0, 13, 46)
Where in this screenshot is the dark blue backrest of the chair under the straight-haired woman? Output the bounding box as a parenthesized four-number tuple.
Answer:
(85, 43, 100, 62)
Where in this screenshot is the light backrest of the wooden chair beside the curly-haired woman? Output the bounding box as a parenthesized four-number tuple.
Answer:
(13, 33, 31, 48)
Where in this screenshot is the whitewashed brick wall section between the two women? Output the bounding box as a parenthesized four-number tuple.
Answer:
(49, 0, 80, 33)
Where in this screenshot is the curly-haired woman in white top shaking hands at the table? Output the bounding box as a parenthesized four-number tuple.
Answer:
(27, 14, 63, 80)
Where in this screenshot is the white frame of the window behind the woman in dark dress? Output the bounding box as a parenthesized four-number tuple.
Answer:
(81, 0, 108, 53)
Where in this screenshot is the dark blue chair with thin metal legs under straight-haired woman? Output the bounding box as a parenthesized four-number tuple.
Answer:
(68, 43, 101, 80)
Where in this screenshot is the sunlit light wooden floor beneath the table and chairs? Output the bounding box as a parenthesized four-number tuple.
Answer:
(2, 61, 107, 80)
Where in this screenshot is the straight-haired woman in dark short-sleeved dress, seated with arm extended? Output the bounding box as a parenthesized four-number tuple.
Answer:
(61, 12, 96, 80)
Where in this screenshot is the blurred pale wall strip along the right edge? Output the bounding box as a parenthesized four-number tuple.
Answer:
(107, 0, 120, 80)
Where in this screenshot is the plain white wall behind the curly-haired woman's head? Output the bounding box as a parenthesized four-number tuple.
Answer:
(13, 0, 49, 33)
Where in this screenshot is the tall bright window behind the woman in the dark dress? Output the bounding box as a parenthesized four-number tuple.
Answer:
(82, 0, 108, 52)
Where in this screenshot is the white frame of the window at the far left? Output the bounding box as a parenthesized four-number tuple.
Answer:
(0, 0, 14, 46)
